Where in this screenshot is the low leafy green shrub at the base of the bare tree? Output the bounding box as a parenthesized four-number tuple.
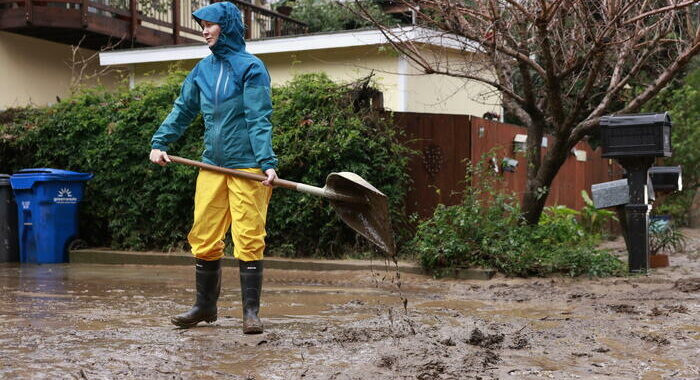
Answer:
(412, 159, 624, 276)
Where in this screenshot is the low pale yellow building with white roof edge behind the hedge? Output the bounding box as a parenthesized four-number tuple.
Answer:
(100, 27, 502, 115)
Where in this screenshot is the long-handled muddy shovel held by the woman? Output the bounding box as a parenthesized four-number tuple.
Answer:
(168, 155, 396, 257)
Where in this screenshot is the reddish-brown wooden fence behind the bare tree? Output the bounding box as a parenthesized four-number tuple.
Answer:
(394, 113, 622, 217)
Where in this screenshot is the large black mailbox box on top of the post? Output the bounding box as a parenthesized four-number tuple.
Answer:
(600, 112, 671, 158)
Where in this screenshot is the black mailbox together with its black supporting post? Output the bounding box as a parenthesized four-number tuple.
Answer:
(600, 113, 671, 273)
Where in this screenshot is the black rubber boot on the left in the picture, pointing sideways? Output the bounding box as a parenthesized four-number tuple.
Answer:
(170, 259, 221, 328)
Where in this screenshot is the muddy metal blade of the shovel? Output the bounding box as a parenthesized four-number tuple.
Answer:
(325, 172, 396, 256)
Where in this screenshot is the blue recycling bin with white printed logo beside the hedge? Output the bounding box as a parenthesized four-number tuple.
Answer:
(10, 168, 93, 264)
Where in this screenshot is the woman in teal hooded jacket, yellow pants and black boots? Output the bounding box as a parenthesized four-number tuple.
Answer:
(150, 2, 277, 334)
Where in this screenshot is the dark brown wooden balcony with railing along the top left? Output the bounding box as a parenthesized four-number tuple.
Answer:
(0, 0, 307, 48)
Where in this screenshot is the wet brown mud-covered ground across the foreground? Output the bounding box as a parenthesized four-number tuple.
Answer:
(0, 230, 700, 380)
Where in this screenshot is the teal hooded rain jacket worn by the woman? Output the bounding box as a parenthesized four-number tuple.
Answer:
(151, 2, 277, 171)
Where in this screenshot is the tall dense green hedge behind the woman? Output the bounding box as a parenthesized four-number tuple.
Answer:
(0, 72, 408, 256)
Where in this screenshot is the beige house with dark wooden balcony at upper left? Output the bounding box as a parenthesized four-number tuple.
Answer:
(0, 0, 306, 110)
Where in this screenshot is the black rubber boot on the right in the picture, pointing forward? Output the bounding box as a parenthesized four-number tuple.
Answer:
(239, 260, 263, 334)
